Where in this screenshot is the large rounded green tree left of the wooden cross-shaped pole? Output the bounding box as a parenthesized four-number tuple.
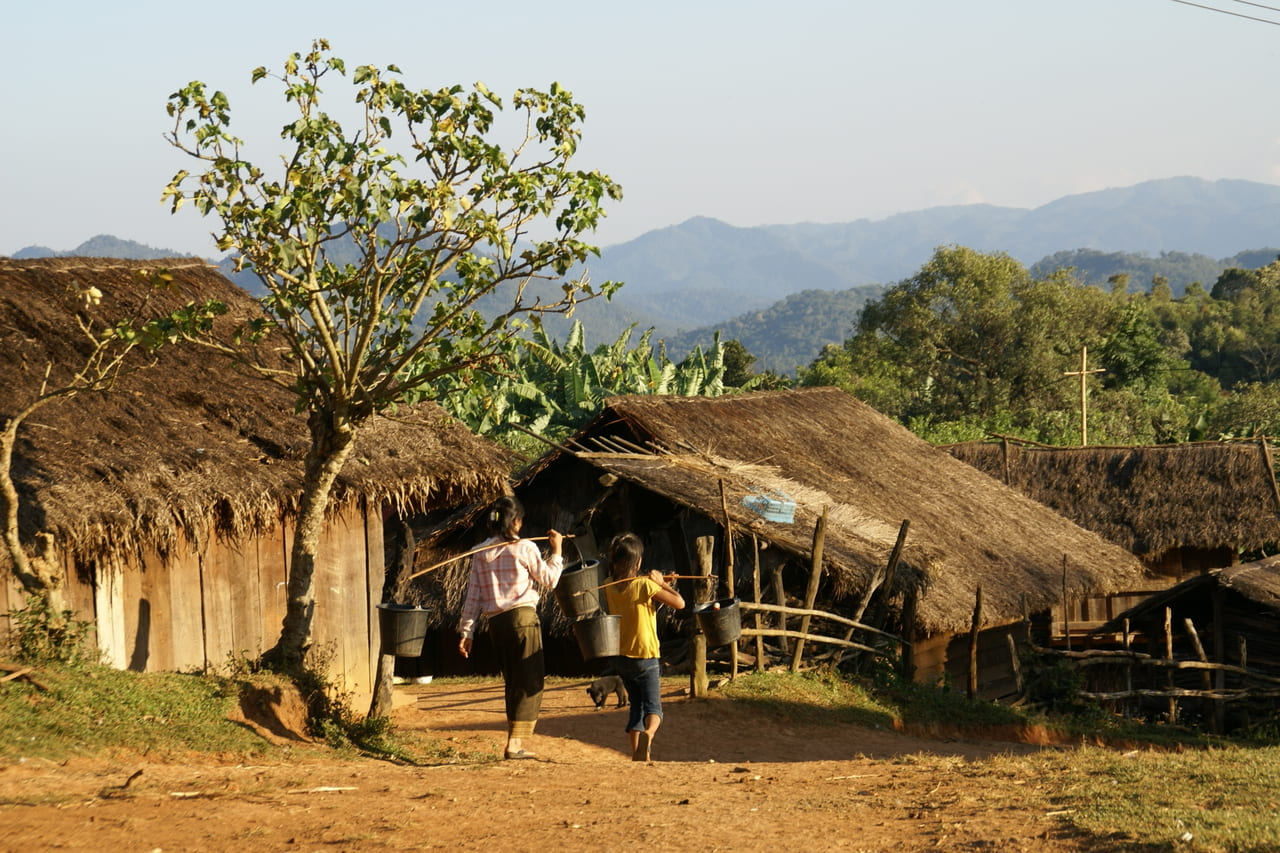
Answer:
(801, 247, 1119, 425)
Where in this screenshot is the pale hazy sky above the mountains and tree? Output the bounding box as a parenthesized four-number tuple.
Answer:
(0, 0, 1280, 257)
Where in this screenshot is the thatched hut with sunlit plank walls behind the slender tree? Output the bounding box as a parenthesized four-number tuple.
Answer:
(0, 257, 508, 686)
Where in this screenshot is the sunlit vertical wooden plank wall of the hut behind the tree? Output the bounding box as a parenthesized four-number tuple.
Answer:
(0, 506, 384, 693)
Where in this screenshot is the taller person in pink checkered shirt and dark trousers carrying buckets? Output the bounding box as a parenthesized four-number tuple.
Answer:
(458, 494, 564, 758)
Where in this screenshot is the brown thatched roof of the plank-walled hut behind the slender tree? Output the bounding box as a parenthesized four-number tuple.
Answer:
(0, 257, 508, 568)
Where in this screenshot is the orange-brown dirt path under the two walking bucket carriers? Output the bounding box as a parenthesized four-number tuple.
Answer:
(0, 680, 1121, 853)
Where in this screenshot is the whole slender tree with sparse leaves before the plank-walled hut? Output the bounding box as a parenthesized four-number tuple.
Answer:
(164, 40, 621, 666)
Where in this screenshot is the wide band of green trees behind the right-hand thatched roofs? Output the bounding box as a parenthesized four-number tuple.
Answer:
(801, 246, 1280, 443)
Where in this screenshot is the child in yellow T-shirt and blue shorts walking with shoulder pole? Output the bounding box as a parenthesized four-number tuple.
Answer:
(604, 533, 685, 761)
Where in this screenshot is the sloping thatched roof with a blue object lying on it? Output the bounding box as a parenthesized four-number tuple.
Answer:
(522, 388, 1143, 633)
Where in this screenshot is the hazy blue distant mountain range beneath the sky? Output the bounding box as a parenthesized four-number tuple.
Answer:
(15, 178, 1280, 373)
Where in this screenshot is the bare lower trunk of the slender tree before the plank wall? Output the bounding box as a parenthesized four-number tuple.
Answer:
(266, 411, 356, 669)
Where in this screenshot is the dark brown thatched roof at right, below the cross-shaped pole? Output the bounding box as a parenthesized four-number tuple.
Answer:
(946, 441, 1280, 557)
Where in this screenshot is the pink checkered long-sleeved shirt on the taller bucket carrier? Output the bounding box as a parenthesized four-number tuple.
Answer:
(458, 537, 564, 637)
